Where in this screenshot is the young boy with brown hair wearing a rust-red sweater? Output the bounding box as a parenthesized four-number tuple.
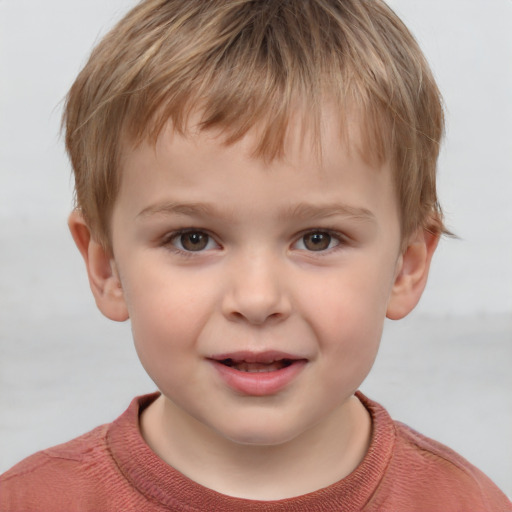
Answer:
(0, 0, 512, 511)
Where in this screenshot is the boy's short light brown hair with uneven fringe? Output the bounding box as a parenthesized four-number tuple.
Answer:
(63, 0, 444, 246)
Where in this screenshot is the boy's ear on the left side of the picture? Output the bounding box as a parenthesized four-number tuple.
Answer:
(68, 210, 129, 322)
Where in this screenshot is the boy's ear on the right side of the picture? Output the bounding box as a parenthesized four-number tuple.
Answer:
(386, 228, 439, 320)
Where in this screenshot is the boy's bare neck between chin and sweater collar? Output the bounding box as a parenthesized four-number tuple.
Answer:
(141, 396, 371, 500)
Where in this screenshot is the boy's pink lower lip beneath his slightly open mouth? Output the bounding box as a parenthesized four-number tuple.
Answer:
(210, 359, 306, 396)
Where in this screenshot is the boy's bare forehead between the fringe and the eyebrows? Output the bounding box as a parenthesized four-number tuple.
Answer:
(117, 111, 396, 228)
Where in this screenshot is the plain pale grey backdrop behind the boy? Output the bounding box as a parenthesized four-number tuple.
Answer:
(0, 0, 512, 495)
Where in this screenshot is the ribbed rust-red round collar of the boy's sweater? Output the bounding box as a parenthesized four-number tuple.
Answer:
(107, 392, 395, 512)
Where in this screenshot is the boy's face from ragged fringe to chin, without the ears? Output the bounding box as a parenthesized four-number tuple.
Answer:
(93, 114, 424, 444)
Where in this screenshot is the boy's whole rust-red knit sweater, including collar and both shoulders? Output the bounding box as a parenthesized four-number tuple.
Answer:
(0, 393, 512, 512)
